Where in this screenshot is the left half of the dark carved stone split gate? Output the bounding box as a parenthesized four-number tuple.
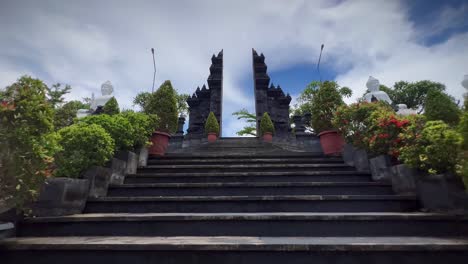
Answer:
(186, 50, 223, 141)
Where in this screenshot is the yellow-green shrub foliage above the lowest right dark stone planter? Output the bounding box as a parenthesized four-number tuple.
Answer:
(399, 121, 462, 174)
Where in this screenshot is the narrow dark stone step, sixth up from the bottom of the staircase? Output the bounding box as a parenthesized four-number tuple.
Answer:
(138, 163, 355, 173)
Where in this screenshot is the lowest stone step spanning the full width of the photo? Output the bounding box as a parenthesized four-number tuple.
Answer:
(0, 236, 468, 264)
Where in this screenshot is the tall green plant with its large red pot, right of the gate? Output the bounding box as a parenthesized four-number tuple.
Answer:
(310, 81, 352, 155)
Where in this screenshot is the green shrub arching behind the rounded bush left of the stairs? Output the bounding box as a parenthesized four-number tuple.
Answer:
(78, 114, 135, 151)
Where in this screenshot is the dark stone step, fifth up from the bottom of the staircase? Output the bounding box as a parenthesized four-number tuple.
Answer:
(125, 171, 371, 183)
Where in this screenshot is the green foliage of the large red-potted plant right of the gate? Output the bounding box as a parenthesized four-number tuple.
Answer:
(308, 81, 352, 133)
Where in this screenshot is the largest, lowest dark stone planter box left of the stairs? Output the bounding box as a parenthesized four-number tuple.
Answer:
(33, 178, 89, 216)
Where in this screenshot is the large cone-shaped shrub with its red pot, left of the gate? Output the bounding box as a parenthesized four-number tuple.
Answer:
(144, 81, 178, 156)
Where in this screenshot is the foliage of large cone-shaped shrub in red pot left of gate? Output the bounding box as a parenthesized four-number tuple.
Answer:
(144, 81, 178, 133)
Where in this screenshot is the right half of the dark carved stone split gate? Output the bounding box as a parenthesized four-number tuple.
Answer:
(252, 49, 288, 139)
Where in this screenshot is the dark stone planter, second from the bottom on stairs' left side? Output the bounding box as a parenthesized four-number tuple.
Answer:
(83, 166, 112, 197)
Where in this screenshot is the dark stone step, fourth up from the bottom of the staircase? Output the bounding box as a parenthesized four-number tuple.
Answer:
(107, 182, 393, 197)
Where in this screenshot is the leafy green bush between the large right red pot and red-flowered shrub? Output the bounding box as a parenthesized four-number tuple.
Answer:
(332, 102, 393, 149)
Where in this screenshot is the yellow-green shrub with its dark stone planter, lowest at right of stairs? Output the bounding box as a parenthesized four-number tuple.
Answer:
(400, 121, 464, 210)
